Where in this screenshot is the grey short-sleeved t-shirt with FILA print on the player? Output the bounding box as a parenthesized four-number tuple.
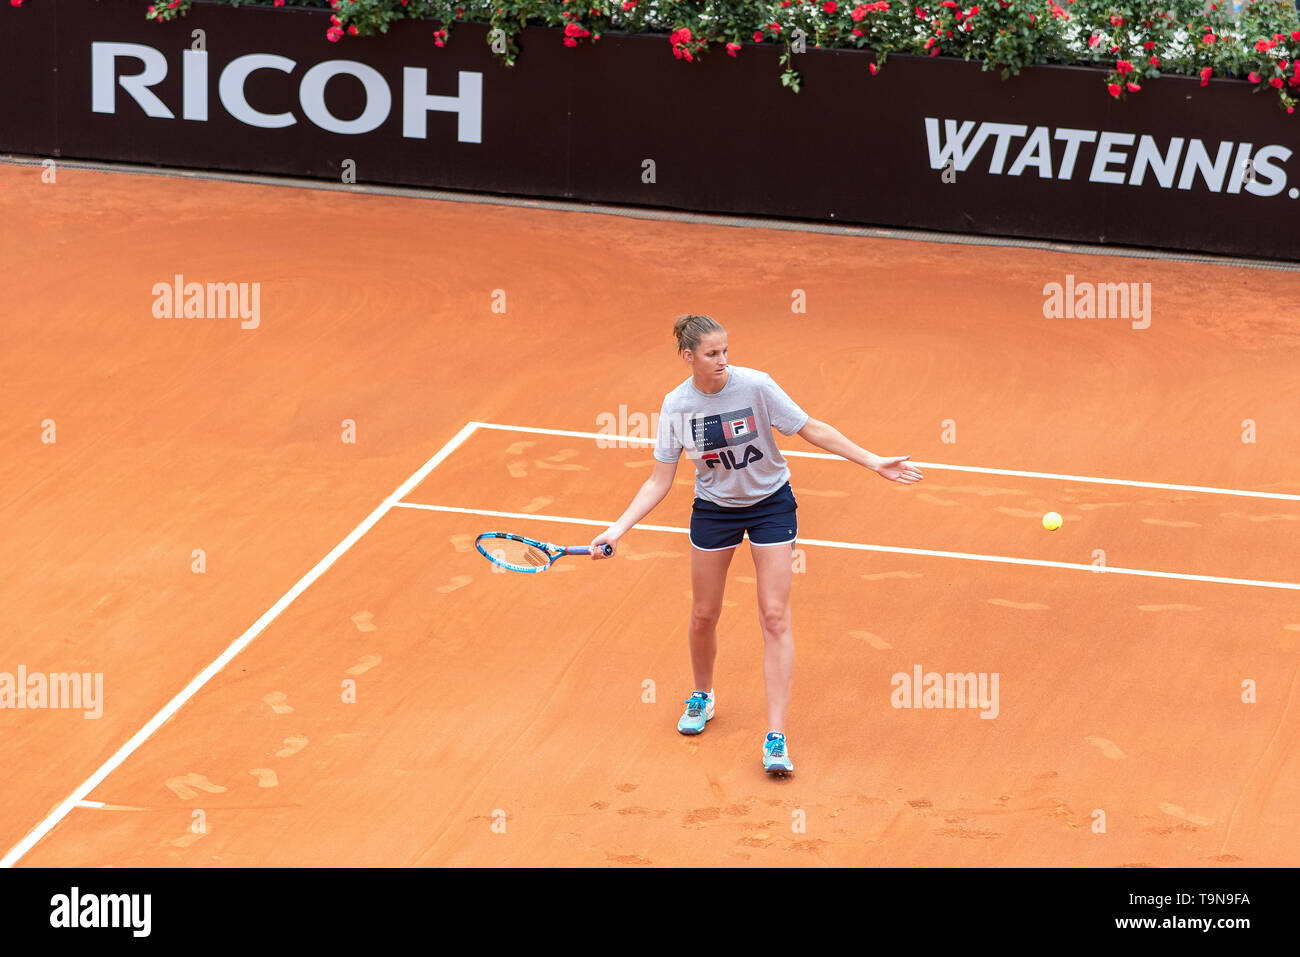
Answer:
(654, 365, 809, 508)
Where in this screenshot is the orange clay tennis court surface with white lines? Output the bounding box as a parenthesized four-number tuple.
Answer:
(0, 165, 1300, 867)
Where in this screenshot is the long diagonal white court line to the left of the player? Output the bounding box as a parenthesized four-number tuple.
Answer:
(0, 423, 475, 867)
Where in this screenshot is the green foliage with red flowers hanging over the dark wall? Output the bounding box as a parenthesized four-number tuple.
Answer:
(148, 0, 1300, 113)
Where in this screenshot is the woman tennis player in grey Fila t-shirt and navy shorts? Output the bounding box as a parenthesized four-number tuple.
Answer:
(592, 316, 922, 774)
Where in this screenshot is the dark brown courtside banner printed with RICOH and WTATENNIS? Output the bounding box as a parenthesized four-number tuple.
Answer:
(0, 0, 1300, 260)
